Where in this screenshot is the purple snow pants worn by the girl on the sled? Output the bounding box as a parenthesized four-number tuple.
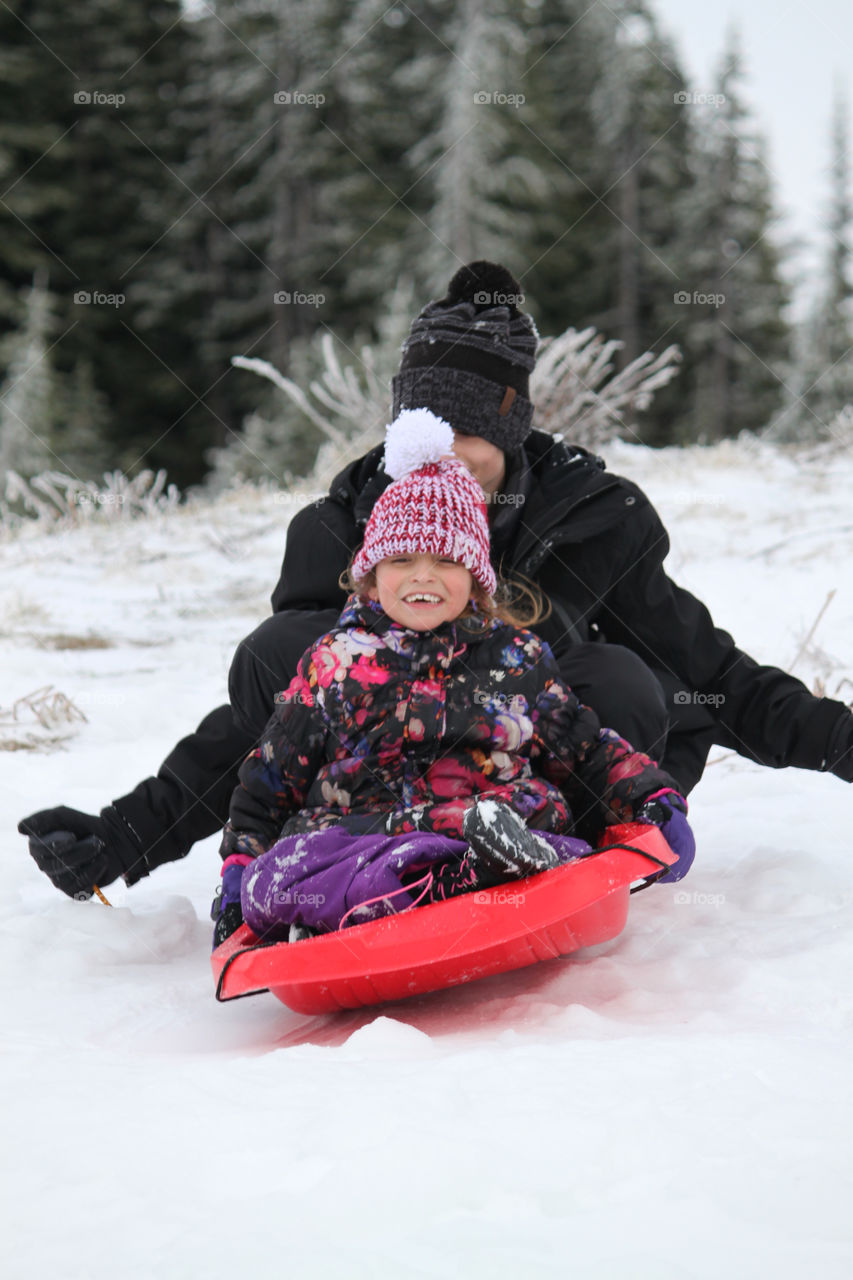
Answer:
(235, 827, 589, 940)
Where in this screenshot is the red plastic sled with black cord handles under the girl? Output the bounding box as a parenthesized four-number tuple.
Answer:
(210, 823, 676, 1014)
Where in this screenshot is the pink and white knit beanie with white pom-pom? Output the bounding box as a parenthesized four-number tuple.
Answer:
(352, 408, 497, 595)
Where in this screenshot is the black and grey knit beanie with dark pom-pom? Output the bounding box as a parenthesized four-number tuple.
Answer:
(391, 262, 539, 453)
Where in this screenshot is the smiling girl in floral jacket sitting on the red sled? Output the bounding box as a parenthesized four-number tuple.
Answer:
(211, 410, 692, 946)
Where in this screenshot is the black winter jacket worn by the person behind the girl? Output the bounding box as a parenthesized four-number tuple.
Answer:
(114, 430, 853, 870)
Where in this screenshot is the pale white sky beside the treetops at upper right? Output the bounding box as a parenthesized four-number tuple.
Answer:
(651, 0, 853, 309)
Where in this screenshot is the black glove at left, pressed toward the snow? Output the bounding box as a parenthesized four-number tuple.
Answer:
(18, 805, 149, 899)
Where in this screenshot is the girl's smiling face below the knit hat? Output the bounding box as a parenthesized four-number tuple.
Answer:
(368, 554, 474, 631)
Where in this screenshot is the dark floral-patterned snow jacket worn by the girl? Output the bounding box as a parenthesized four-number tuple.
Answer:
(220, 595, 675, 858)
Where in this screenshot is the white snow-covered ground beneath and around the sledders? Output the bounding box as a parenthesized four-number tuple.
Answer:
(0, 444, 853, 1280)
